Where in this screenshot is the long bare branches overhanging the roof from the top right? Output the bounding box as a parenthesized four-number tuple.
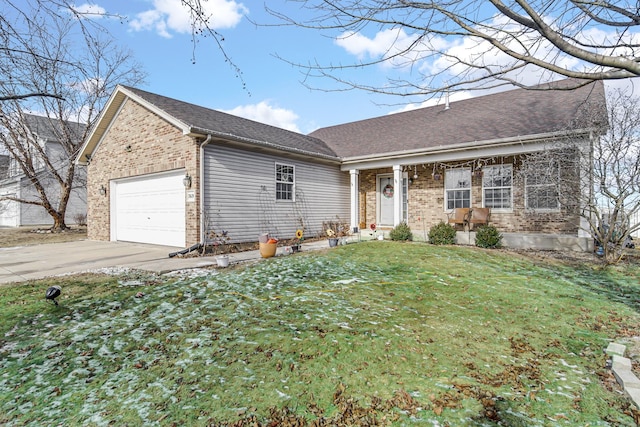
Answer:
(267, 0, 640, 96)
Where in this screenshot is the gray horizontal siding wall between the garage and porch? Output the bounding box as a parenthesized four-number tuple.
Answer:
(204, 144, 350, 242)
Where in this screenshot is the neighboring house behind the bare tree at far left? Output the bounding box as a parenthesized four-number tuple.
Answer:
(0, 115, 87, 227)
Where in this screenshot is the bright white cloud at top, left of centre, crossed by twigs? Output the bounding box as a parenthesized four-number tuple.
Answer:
(129, 0, 249, 38)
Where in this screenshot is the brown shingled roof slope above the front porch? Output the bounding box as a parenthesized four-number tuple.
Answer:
(310, 79, 604, 158)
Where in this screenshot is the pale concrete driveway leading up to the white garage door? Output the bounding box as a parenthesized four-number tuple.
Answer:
(0, 240, 220, 283)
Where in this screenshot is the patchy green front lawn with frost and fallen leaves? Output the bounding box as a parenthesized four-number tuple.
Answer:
(0, 242, 640, 426)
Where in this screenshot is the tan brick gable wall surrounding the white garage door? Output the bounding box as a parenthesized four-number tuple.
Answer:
(87, 100, 200, 246)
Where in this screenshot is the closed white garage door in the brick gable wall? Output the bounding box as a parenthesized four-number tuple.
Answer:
(111, 171, 185, 247)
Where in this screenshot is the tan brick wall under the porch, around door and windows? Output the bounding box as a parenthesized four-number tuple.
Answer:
(359, 159, 579, 237)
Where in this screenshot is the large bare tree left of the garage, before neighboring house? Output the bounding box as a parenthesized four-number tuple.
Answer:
(0, 1, 144, 229)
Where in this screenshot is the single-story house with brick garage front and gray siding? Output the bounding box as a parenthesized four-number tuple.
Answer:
(77, 80, 604, 250)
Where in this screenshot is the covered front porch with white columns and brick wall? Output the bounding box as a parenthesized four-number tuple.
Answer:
(343, 135, 593, 251)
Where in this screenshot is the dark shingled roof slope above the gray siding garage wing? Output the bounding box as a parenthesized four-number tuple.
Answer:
(123, 86, 337, 157)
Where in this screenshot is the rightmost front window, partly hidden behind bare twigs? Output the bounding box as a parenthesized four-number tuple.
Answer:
(525, 161, 560, 210)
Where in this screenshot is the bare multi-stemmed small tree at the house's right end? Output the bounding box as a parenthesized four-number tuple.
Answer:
(521, 91, 640, 263)
